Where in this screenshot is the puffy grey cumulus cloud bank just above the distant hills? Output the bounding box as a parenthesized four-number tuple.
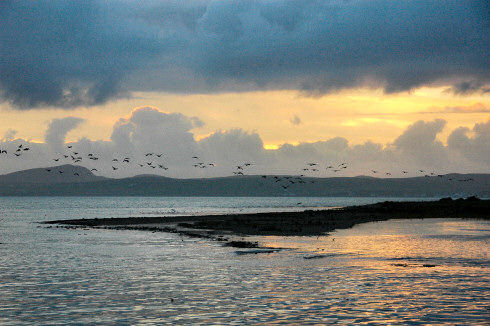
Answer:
(0, 111, 490, 178)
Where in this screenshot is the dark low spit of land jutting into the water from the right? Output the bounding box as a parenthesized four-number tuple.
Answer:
(47, 197, 490, 249)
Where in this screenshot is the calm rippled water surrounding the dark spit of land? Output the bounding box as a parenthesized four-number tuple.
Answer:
(0, 197, 490, 325)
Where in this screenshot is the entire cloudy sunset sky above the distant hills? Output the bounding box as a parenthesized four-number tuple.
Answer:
(0, 0, 490, 178)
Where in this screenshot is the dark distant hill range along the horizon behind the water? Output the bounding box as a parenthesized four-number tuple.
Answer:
(0, 165, 490, 198)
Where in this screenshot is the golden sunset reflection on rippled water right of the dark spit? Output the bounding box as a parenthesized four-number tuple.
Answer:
(253, 219, 490, 325)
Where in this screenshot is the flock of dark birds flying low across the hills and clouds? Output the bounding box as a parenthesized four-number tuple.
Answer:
(0, 144, 474, 190)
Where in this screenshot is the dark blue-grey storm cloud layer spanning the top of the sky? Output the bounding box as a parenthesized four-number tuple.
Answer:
(0, 0, 490, 108)
